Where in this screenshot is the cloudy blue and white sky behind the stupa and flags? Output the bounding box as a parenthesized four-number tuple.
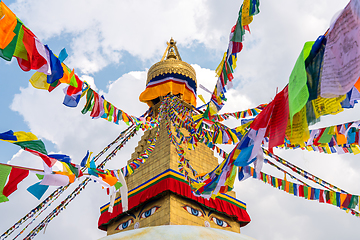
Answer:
(0, 0, 360, 240)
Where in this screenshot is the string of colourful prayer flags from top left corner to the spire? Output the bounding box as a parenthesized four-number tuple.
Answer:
(0, 2, 151, 127)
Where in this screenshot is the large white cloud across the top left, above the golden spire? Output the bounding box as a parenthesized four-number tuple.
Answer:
(11, 0, 236, 73)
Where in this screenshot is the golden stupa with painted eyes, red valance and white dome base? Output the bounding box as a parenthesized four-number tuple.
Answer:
(98, 39, 252, 239)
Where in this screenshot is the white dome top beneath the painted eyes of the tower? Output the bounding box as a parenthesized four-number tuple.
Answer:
(100, 225, 255, 240)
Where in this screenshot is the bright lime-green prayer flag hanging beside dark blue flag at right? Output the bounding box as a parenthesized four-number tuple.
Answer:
(288, 41, 314, 125)
